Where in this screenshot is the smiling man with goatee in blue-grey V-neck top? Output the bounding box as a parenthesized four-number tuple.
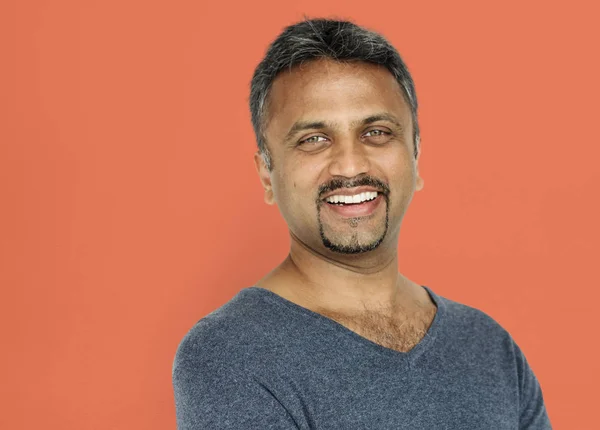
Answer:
(173, 20, 551, 430)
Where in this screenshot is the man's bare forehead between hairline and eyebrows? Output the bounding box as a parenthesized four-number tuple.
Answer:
(265, 60, 410, 134)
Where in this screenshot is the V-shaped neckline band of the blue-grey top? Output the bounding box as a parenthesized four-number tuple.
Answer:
(245, 285, 446, 362)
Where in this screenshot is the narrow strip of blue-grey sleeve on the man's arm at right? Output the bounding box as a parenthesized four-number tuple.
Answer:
(514, 343, 552, 430)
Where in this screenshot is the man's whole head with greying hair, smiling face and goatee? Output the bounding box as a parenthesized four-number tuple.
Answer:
(250, 20, 422, 254)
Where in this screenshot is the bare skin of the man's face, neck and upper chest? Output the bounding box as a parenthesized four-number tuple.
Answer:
(254, 60, 435, 350)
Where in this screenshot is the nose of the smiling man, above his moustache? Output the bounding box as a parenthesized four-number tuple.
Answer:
(329, 137, 371, 178)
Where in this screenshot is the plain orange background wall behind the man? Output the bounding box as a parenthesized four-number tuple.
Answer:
(0, 0, 600, 429)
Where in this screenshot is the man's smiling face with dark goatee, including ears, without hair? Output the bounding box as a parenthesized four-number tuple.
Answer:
(255, 60, 423, 254)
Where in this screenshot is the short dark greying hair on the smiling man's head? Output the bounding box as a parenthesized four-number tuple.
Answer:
(250, 19, 420, 170)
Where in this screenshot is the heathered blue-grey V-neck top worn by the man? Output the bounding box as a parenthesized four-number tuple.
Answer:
(173, 286, 551, 430)
